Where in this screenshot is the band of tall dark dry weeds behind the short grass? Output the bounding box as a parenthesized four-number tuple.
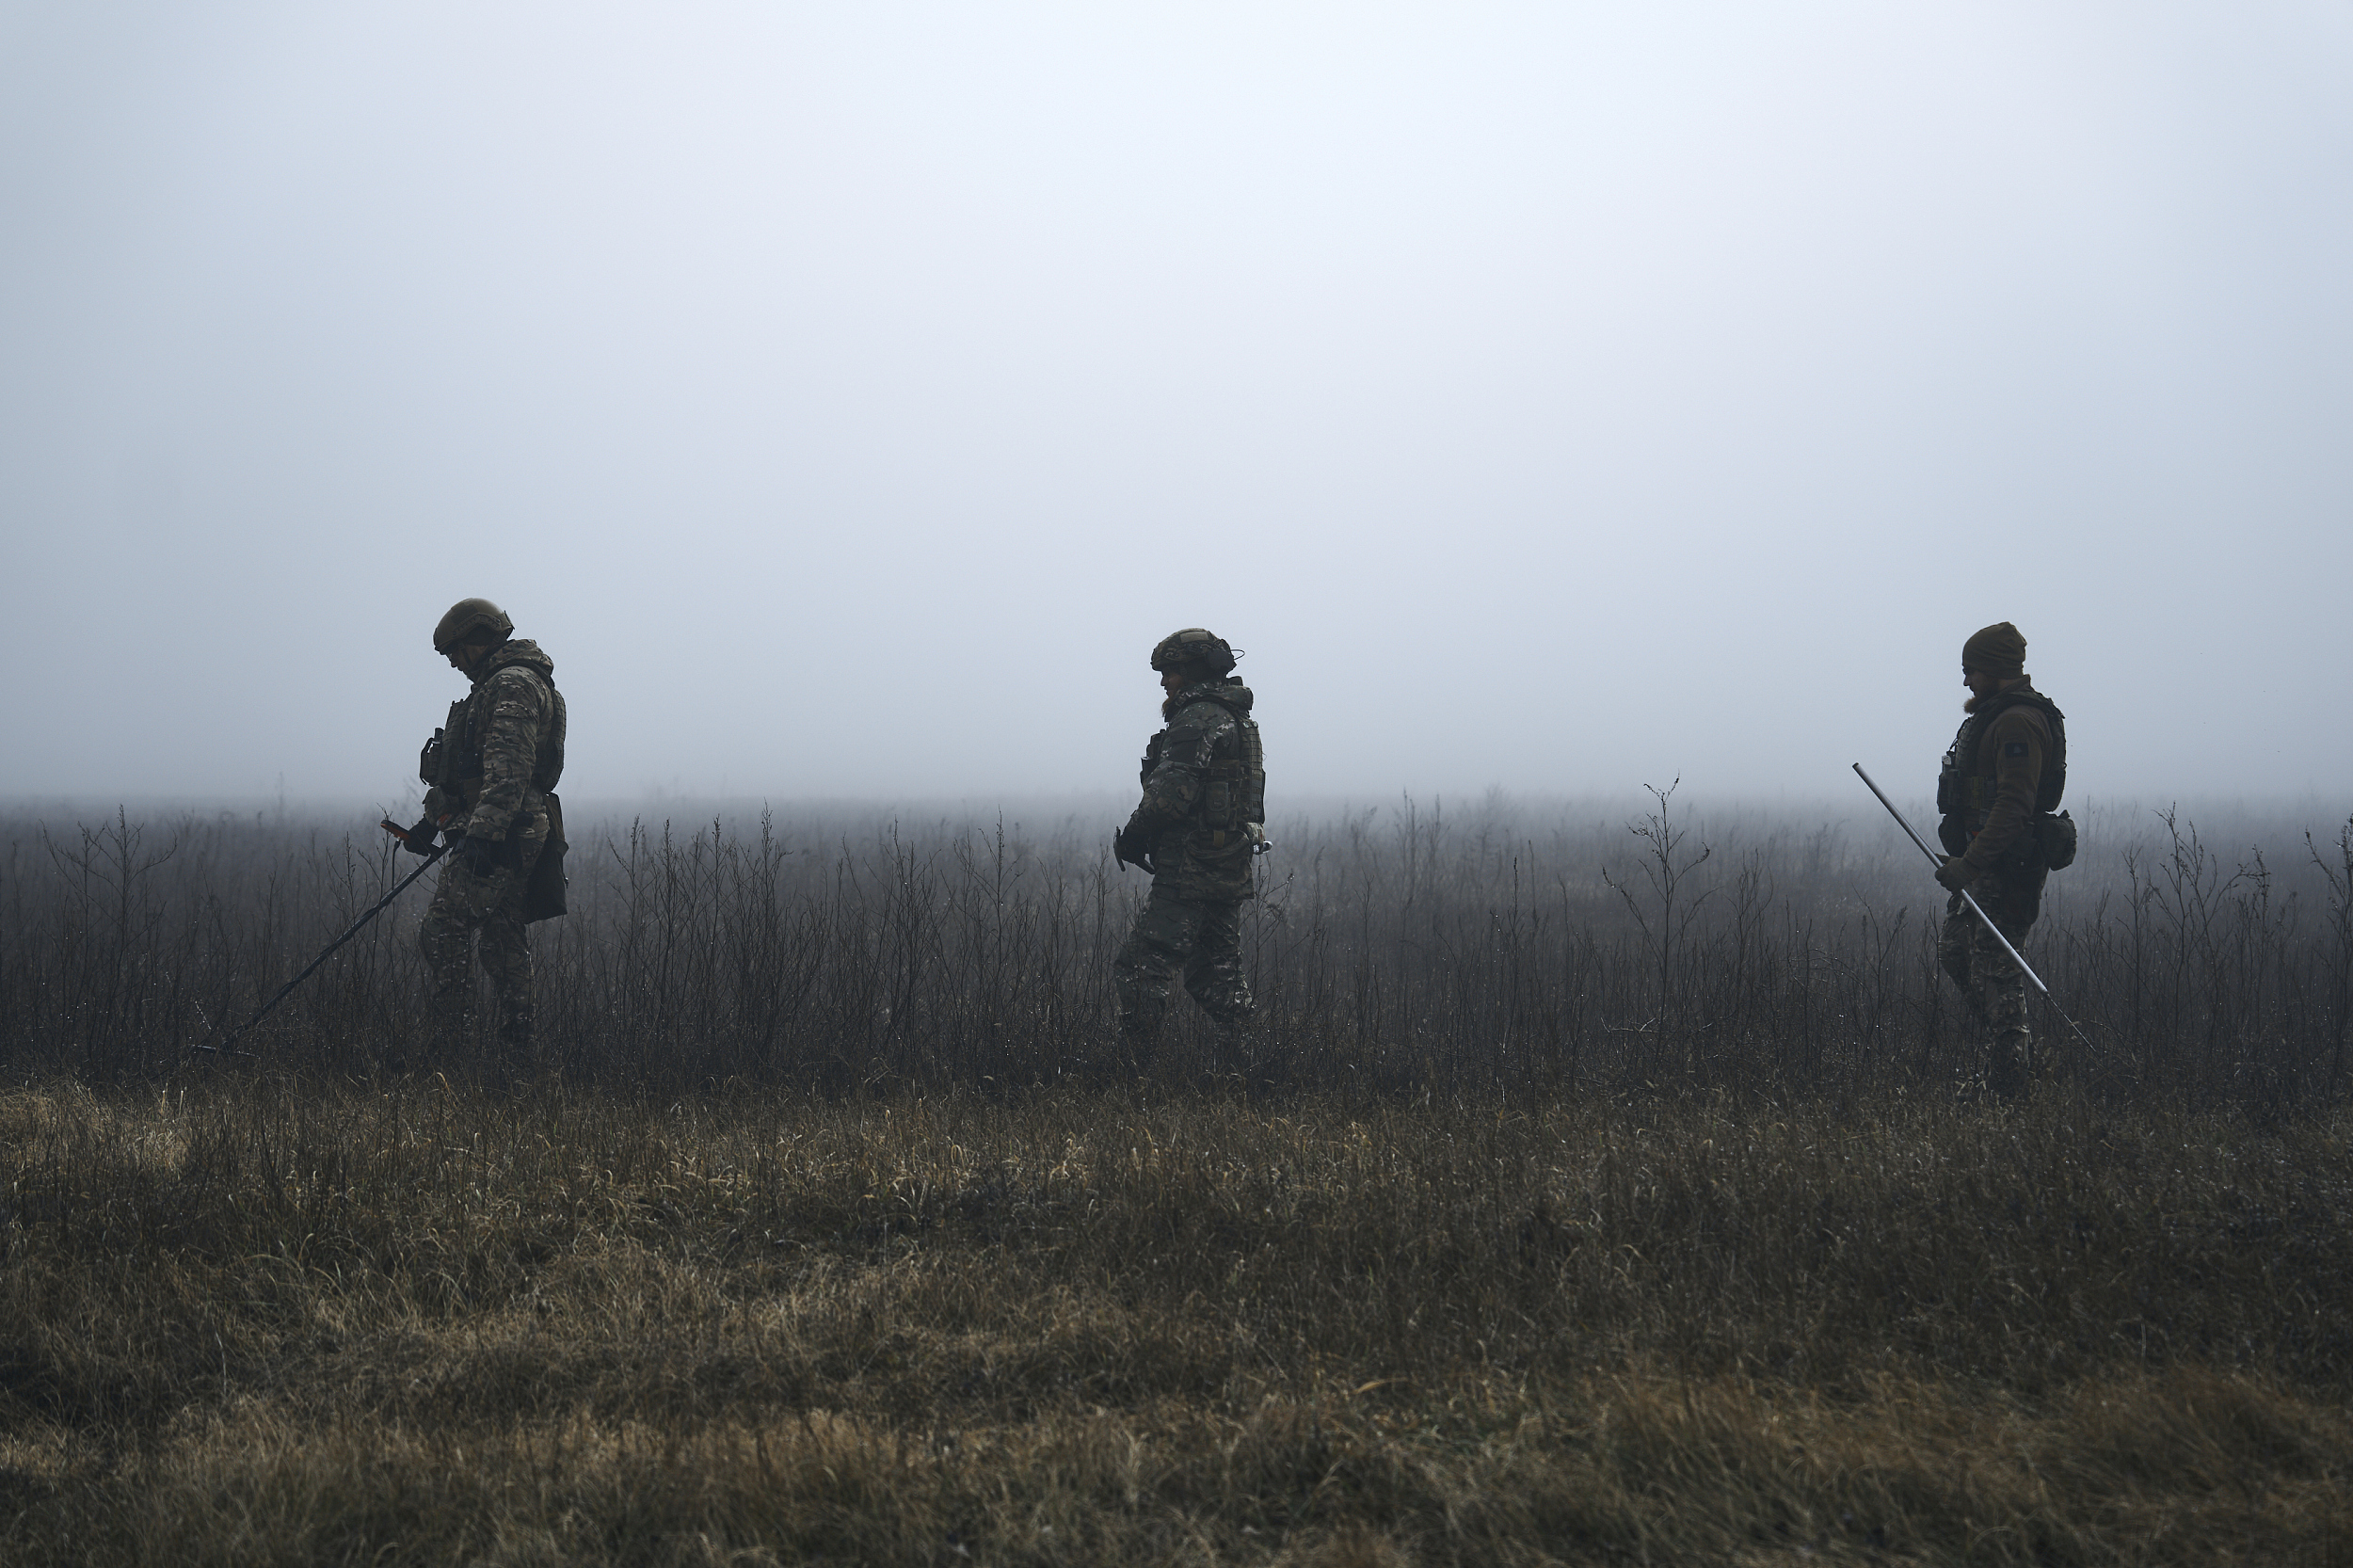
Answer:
(0, 793, 2353, 1107)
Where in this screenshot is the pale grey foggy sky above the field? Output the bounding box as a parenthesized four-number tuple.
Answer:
(0, 0, 2353, 798)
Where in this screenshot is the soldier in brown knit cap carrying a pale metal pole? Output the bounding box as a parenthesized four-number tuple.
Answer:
(1937, 621, 2075, 1099)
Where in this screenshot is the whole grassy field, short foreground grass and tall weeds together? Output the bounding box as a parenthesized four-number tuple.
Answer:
(0, 815, 2353, 1565)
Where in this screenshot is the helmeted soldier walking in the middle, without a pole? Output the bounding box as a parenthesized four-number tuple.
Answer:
(1111, 626, 1266, 1062)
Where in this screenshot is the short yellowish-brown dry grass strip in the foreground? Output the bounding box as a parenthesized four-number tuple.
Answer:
(0, 1074, 2353, 1563)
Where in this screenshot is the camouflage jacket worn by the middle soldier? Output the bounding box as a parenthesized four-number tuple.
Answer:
(1128, 678, 1266, 900)
